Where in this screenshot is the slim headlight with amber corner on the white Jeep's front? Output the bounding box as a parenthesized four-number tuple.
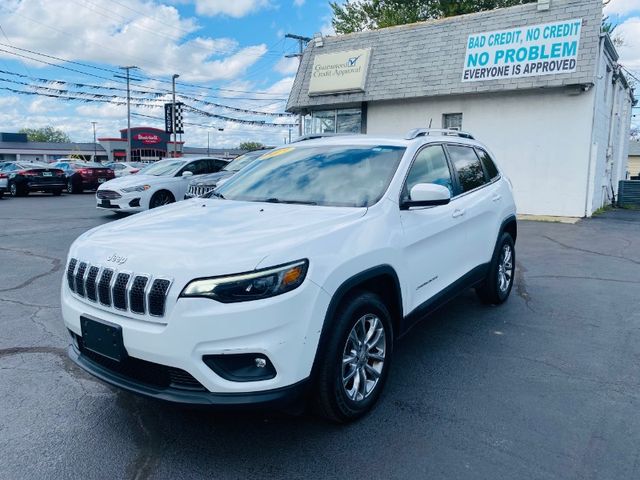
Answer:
(180, 259, 309, 303)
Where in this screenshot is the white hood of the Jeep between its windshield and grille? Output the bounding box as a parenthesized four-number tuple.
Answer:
(70, 198, 367, 280)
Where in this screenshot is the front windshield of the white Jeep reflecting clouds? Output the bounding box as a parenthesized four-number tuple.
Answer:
(216, 145, 405, 207)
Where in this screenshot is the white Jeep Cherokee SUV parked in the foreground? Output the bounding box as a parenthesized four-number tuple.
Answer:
(62, 130, 517, 422)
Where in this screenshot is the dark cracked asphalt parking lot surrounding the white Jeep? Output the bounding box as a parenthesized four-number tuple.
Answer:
(0, 193, 640, 480)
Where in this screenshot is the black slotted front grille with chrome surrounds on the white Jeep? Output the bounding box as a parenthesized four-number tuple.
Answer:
(67, 258, 171, 317)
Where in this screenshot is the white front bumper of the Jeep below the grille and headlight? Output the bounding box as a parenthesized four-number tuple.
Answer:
(62, 279, 330, 398)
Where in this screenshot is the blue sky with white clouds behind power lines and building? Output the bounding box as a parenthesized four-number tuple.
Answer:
(0, 0, 640, 147)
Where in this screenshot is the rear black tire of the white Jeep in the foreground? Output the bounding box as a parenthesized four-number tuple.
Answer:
(476, 232, 516, 305)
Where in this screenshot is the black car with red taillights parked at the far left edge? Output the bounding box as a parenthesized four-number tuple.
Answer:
(2, 162, 65, 197)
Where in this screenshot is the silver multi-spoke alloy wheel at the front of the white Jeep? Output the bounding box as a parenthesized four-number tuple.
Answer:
(342, 314, 387, 402)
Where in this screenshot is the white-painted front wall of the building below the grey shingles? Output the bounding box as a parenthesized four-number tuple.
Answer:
(367, 89, 594, 217)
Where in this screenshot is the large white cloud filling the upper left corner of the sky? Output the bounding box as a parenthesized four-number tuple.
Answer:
(0, 0, 267, 81)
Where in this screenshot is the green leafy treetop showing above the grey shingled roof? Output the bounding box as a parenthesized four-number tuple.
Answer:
(329, 0, 536, 33)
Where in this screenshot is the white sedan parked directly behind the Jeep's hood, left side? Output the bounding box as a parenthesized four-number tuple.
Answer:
(96, 157, 228, 212)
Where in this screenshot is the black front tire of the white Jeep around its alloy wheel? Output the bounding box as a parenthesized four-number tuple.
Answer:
(314, 291, 393, 423)
